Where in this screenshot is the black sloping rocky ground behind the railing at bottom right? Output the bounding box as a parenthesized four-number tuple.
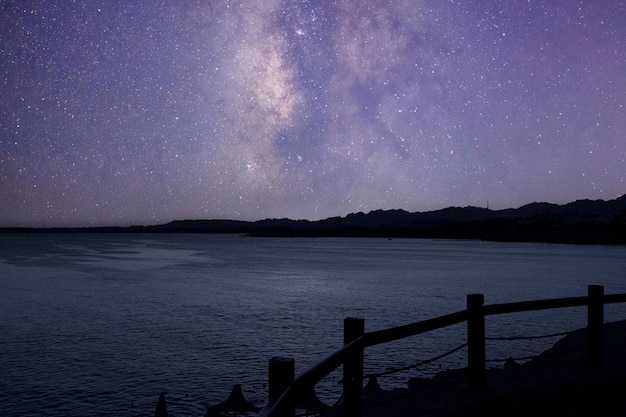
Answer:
(365, 321, 626, 417)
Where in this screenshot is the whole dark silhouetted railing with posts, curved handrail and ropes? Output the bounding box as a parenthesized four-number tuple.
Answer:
(259, 285, 626, 417)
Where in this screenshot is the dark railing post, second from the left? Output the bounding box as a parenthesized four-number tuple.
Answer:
(343, 317, 365, 417)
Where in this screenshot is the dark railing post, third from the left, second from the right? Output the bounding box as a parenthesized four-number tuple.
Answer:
(467, 294, 487, 391)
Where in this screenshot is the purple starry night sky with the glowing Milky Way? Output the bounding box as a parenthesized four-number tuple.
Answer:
(0, 0, 626, 226)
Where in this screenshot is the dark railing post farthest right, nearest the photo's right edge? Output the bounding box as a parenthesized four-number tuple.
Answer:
(587, 285, 604, 369)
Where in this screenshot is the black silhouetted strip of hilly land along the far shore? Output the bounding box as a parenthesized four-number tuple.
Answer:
(0, 195, 626, 244)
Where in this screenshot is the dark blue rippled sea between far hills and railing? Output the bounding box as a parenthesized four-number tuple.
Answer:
(0, 233, 626, 417)
